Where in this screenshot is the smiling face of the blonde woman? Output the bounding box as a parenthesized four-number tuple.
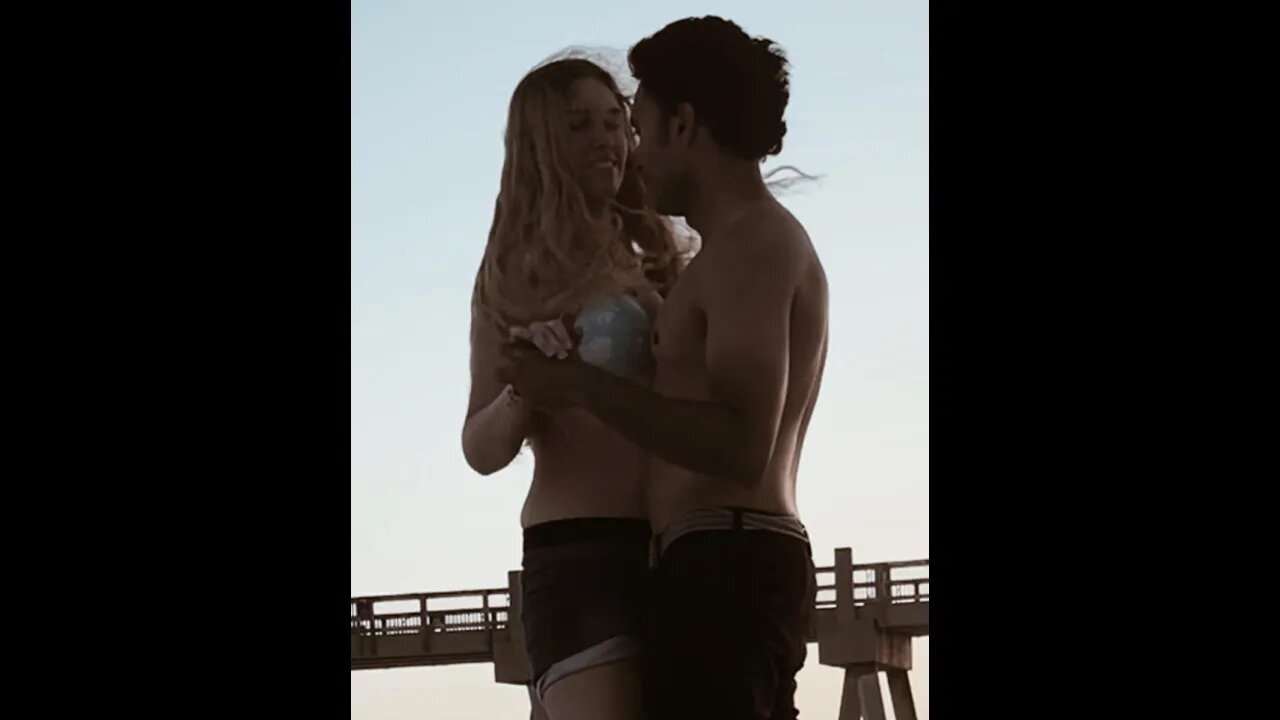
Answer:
(567, 78, 627, 201)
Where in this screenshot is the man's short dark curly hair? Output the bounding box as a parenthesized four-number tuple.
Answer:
(627, 15, 791, 160)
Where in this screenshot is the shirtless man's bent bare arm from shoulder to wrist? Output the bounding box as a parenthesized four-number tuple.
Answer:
(572, 233, 795, 487)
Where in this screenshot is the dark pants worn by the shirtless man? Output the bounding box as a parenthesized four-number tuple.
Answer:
(644, 520, 817, 720)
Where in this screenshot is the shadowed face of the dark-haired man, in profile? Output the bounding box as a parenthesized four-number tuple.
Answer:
(631, 85, 687, 215)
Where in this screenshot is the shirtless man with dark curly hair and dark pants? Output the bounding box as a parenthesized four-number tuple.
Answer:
(494, 18, 827, 720)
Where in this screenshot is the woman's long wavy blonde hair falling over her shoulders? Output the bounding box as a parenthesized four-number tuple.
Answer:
(471, 58, 685, 334)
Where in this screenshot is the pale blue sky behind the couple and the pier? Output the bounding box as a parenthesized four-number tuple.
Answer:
(351, 0, 929, 720)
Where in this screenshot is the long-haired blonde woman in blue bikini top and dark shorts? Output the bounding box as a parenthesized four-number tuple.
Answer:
(462, 59, 678, 720)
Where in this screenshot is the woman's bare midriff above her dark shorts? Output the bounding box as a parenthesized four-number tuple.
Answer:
(520, 409, 648, 528)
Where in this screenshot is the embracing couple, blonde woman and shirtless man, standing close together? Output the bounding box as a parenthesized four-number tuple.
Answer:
(462, 17, 827, 720)
